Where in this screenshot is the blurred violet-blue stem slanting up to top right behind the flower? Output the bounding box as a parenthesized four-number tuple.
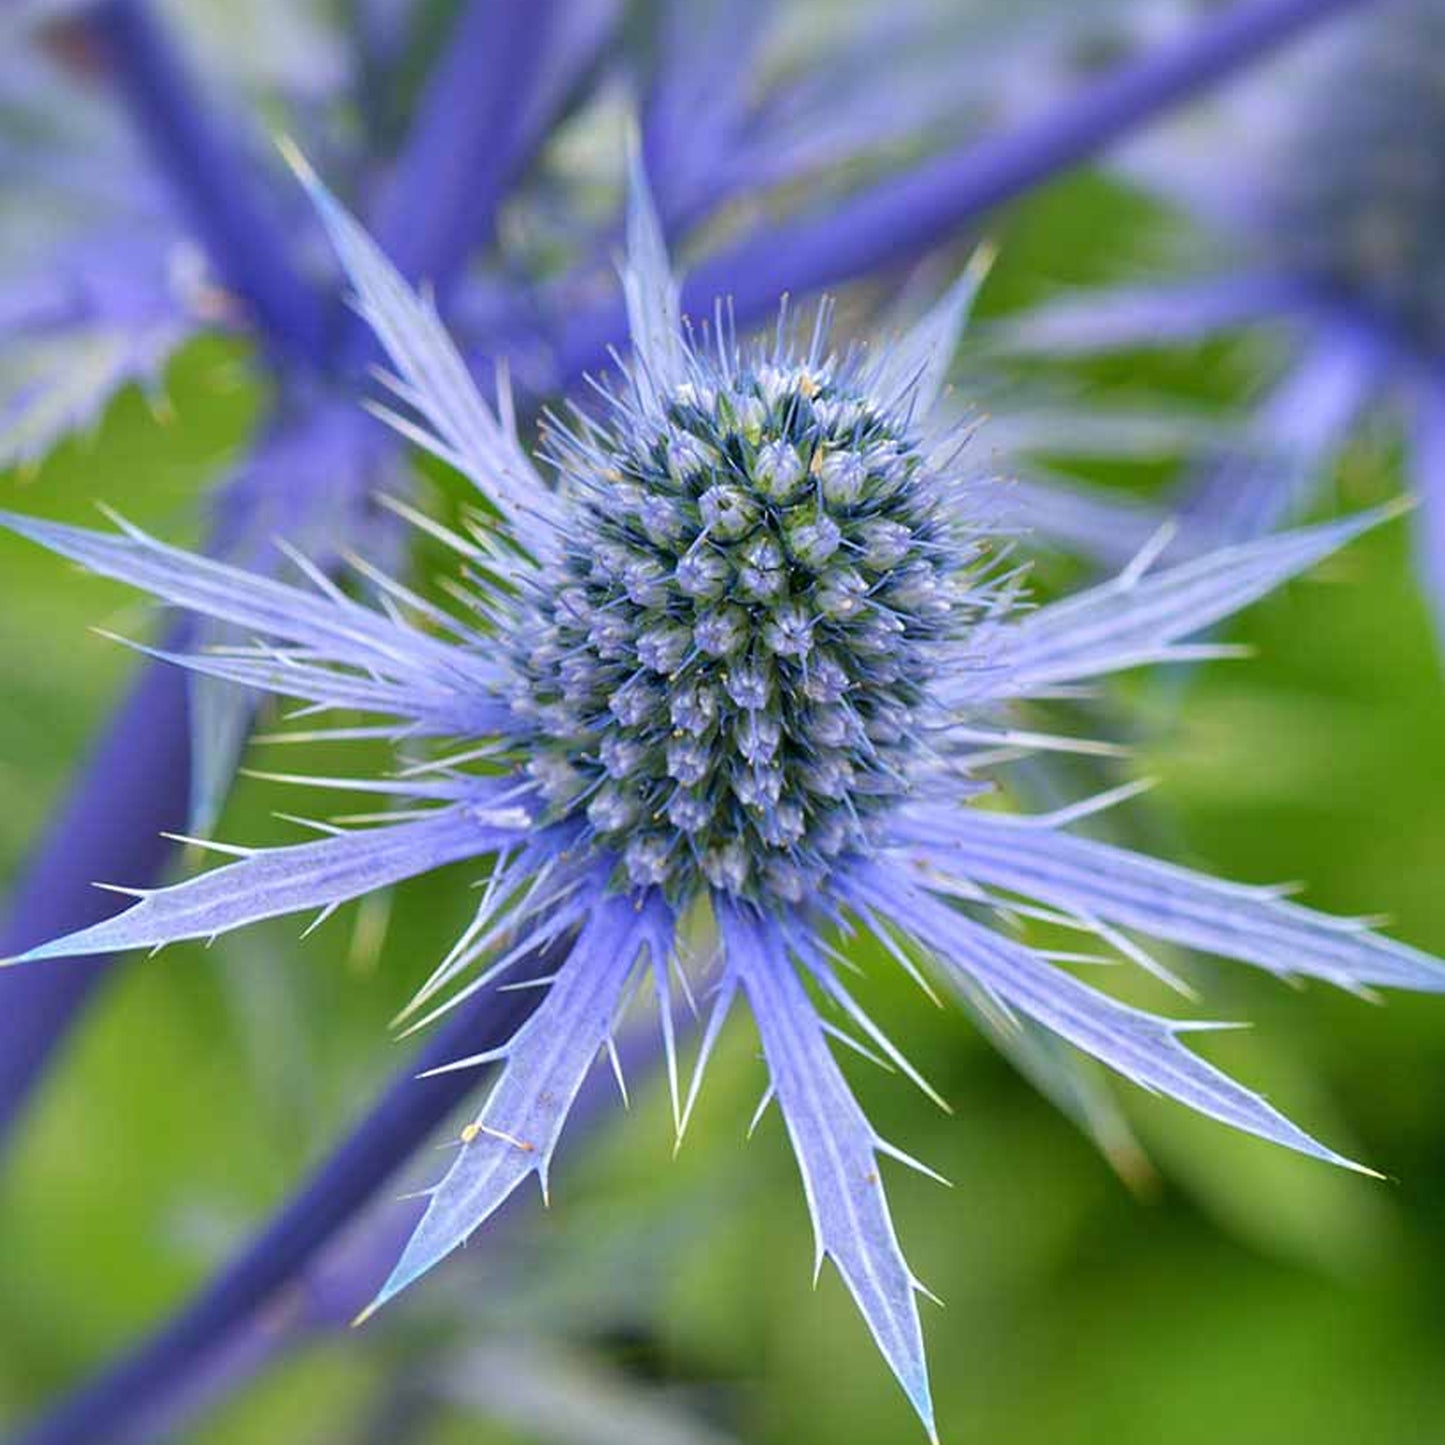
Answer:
(559, 0, 1379, 387)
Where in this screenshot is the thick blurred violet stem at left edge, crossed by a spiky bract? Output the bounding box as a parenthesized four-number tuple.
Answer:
(0, 637, 189, 1139)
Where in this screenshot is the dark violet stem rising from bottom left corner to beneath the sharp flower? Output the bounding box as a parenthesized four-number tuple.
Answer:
(9, 958, 556, 1445)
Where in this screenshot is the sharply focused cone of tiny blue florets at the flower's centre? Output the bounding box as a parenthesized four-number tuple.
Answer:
(514, 351, 957, 902)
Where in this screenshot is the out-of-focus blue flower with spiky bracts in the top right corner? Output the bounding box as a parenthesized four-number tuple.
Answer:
(1007, 0, 1445, 647)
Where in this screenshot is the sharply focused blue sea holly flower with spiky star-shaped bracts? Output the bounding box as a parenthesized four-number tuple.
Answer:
(7, 158, 1445, 1431)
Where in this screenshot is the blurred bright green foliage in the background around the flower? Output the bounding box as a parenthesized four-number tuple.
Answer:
(0, 178, 1445, 1445)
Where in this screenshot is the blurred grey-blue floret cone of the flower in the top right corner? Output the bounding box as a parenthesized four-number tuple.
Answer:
(1269, 0, 1445, 350)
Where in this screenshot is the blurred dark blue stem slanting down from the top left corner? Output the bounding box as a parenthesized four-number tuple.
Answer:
(88, 0, 324, 361)
